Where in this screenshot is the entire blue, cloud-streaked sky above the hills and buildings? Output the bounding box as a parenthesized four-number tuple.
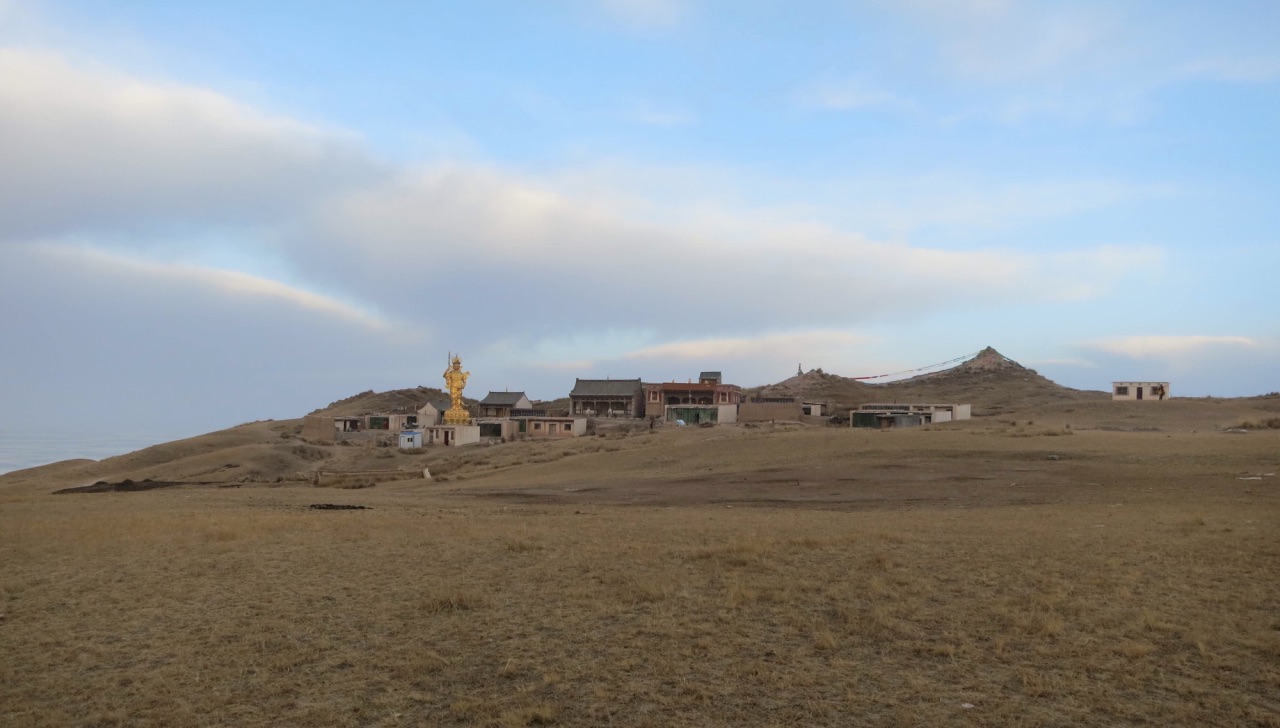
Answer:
(0, 0, 1280, 436)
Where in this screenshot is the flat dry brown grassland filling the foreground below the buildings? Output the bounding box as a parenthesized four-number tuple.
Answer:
(0, 421, 1280, 727)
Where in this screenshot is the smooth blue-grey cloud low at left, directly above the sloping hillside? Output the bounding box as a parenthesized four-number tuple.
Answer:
(0, 244, 435, 436)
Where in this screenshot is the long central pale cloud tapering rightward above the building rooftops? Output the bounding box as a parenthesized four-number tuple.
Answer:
(288, 165, 1153, 336)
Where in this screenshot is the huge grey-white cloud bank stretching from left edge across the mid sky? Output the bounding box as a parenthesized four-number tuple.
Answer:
(0, 46, 1187, 409)
